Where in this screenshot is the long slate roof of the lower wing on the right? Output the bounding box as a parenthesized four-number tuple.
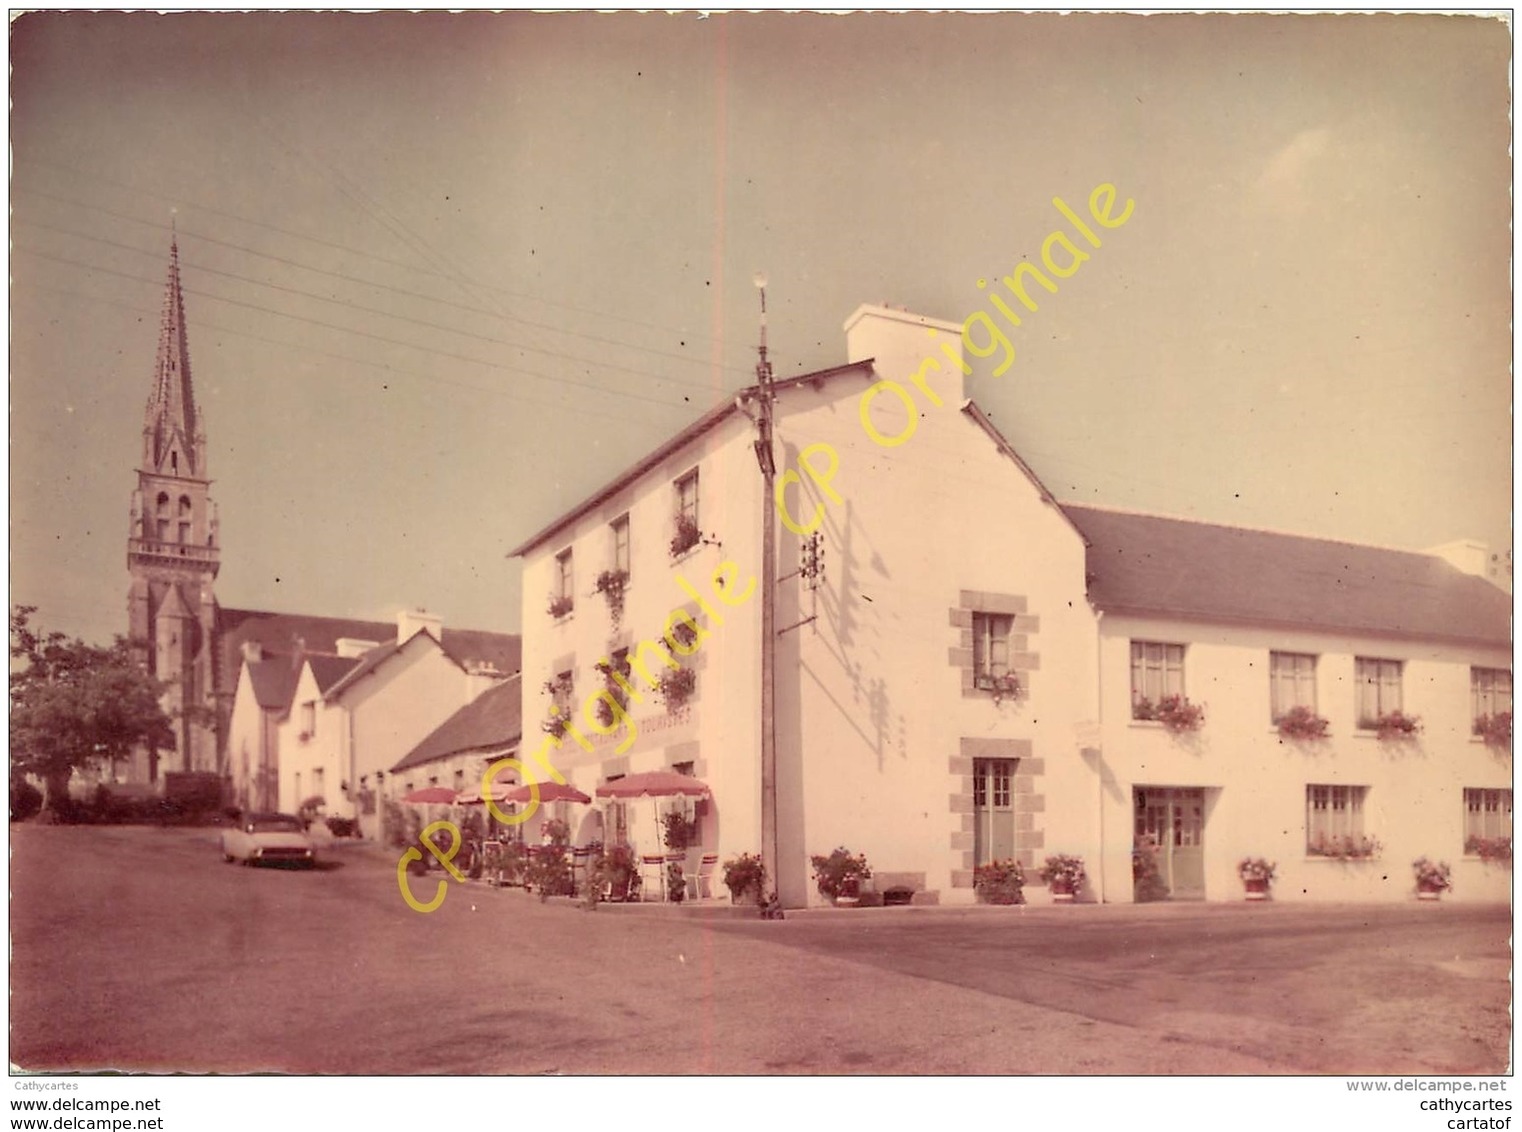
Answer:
(1062, 504, 1511, 647)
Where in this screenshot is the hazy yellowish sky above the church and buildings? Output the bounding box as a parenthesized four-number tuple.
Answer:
(9, 12, 1513, 642)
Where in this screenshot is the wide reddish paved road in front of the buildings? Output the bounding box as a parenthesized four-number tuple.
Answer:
(11, 825, 1511, 1074)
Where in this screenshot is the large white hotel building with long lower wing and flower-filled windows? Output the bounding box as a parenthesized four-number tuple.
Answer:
(514, 307, 1511, 905)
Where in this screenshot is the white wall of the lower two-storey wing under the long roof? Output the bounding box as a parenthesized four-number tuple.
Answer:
(1102, 616, 1511, 902)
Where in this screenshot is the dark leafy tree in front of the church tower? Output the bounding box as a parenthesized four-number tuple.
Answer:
(11, 606, 175, 811)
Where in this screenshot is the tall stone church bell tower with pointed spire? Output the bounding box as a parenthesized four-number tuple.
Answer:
(126, 237, 221, 781)
